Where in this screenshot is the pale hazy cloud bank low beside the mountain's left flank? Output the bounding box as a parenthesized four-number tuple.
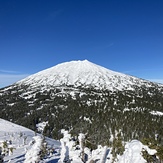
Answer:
(0, 71, 29, 88)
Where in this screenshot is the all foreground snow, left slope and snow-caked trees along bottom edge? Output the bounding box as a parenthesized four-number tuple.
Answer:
(0, 119, 157, 163)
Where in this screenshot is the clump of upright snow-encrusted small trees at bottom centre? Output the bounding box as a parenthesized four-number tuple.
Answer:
(58, 130, 109, 163)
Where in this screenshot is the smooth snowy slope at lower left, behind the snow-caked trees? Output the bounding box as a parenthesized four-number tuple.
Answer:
(0, 119, 60, 163)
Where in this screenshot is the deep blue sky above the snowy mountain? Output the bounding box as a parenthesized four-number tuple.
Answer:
(0, 0, 163, 87)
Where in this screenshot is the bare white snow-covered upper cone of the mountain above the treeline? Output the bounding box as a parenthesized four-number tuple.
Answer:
(17, 60, 155, 90)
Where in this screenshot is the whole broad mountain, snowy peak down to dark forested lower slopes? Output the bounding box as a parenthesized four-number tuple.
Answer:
(0, 60, 163, 162)
